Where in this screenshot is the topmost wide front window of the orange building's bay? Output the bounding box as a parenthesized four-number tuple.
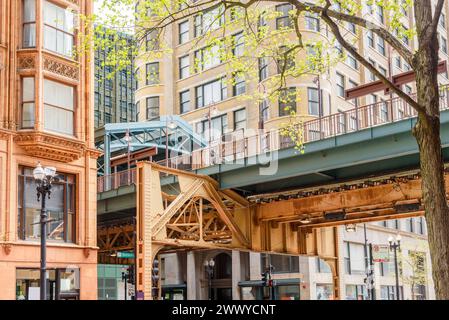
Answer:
(44, 1, 75, 57)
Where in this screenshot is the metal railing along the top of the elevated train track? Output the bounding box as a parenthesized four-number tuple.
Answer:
(98, 85, 449, 192)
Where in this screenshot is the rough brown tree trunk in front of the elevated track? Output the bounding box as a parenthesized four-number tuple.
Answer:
(413, 0, 449, 300)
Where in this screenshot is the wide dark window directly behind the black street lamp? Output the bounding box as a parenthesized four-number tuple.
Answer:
(18, 167, 76, 242)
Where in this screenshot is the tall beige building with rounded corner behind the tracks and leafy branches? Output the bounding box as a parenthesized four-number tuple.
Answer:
(136, 0, 449, 140)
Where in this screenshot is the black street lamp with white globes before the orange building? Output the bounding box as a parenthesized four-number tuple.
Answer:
(33, 162, 56, 300)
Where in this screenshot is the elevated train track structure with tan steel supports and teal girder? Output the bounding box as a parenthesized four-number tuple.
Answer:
(97, 87, 449, 299)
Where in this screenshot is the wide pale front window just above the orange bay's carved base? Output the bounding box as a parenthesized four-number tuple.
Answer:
(44, 79, 75, 135)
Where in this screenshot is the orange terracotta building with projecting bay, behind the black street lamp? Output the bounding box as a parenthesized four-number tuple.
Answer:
(0, 0, 98, 299)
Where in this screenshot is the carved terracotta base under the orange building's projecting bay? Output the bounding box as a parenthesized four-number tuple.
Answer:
(14, 132, 86, 163)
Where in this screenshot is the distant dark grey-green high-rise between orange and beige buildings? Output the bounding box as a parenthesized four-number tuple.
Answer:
(95, 29, 137, 129)
